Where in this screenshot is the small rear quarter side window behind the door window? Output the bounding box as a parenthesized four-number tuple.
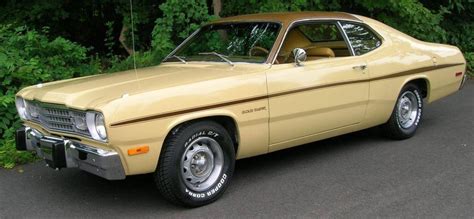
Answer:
(342, 23, 382, 55)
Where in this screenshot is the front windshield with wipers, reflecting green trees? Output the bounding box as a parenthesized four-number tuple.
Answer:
(165, 22, 280, 64)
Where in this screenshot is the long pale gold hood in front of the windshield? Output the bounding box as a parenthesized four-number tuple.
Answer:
(18, 63, 269, 110)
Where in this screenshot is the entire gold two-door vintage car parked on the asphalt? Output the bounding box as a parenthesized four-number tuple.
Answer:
(16, 12, 466, 206)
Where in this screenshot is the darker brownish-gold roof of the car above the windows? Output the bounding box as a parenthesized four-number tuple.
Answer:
(212, 11, 361, 24)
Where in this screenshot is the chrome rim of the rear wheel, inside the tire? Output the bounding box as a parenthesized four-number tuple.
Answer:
(397, 91, 418, 129)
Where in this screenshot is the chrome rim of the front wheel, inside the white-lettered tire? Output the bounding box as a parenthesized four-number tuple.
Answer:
(181, 137, 224, 192)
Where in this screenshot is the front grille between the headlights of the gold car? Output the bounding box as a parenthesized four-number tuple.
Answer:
(27, 101, 90, 137)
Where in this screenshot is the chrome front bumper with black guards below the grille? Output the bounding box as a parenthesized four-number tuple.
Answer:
(16, 127, 125, 180)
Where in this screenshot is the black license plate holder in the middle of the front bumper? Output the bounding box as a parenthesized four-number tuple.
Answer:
(40, 138, 67, 169)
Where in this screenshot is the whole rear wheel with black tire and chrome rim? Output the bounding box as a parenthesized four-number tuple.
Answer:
(382, 84, 423, 140)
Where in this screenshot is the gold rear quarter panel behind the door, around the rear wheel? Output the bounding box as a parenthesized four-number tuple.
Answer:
(359, 16, 466, 127)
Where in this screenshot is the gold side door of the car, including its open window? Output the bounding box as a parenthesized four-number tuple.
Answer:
(267, 21, 369, 146)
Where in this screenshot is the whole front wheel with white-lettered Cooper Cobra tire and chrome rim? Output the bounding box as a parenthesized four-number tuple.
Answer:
(154, 121, 235, 207)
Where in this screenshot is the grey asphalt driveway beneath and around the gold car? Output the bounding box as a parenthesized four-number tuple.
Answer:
(0, 81, 474, 218)
